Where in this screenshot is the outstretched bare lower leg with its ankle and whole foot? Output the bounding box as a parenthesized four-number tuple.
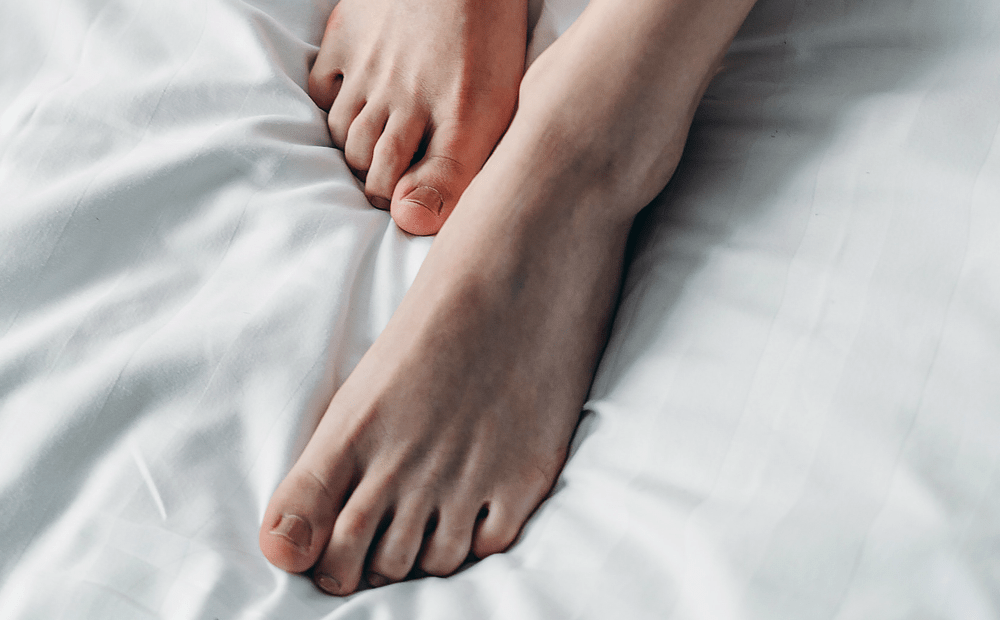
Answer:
(260, 0, 752, 595)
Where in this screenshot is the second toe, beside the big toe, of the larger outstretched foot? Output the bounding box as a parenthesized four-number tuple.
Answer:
(313, 477, 388, 596)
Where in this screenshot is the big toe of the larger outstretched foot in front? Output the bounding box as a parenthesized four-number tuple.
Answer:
(259, 469, 337, 573)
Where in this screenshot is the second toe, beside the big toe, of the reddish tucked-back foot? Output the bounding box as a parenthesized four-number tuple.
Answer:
(365, 111, 427, 210)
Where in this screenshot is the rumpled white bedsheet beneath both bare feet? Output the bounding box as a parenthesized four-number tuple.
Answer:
(0, 0, 1000, 620)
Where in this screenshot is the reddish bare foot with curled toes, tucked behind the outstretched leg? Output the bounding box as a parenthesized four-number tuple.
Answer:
(309, 0, 527, 235)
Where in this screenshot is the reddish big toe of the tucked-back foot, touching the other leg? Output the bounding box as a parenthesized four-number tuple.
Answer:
(392, 129, 480, 235)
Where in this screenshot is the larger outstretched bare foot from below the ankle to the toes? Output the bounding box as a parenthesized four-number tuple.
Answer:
(260, 168, 628, 595)
